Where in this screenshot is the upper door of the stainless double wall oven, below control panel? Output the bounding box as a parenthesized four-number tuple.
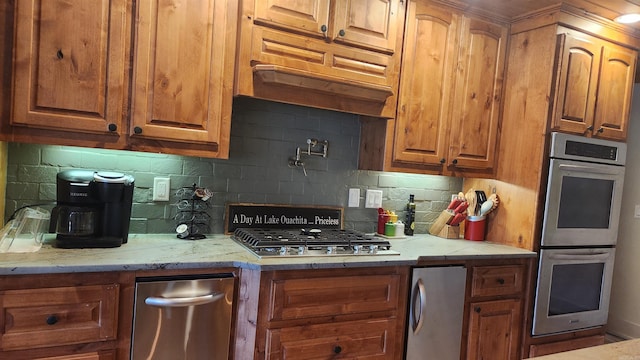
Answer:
(541, 159, 624, 246)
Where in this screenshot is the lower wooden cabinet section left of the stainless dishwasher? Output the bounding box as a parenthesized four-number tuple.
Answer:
(0, 273, 133, 360)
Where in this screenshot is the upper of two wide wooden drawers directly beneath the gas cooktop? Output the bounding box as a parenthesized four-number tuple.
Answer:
(269, 275, 401, 321)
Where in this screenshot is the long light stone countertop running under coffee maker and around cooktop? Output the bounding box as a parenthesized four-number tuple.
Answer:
(0, 234, 536, 275)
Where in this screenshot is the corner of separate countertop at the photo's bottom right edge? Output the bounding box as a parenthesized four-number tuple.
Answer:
(530, 339, 640, 360)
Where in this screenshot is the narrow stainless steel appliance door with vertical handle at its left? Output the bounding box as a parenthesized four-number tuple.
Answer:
(406, 266, 467, 360)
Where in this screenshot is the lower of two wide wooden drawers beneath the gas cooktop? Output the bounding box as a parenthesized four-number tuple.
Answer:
(266, 318, 396, 360)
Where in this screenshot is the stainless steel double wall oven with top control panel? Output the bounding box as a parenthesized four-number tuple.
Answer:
(532, 133, 626, 335)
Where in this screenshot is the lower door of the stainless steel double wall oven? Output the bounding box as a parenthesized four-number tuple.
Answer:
(532, 248, 615, 335)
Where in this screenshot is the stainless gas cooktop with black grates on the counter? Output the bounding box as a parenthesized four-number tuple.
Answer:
(231, 228, 398, 257)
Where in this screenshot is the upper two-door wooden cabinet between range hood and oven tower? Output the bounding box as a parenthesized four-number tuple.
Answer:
(360, 1, 508, 176)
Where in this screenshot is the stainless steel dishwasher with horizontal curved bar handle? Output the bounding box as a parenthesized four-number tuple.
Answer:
(131, 274, 235, 360)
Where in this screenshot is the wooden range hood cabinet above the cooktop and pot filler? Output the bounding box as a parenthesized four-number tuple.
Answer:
(235, 0, 406, 118)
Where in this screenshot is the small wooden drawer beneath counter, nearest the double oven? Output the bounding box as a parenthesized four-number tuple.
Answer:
(471, 265, 524, 297)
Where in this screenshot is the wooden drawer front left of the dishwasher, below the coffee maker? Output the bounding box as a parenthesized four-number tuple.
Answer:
(0, 284, 119, 350)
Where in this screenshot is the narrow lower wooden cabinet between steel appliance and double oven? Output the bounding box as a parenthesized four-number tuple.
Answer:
(466, 262, 528, 360)
